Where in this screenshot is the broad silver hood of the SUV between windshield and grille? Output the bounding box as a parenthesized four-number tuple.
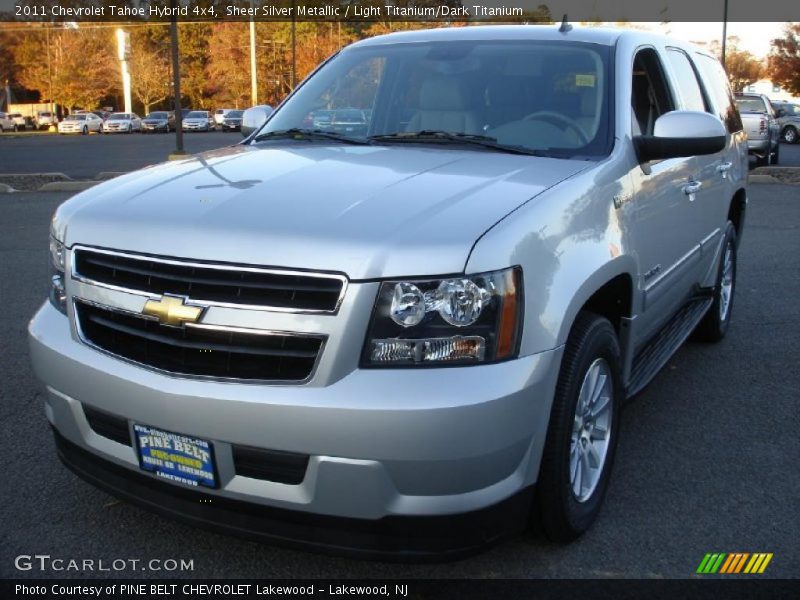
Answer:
(54, 142, 592, 280)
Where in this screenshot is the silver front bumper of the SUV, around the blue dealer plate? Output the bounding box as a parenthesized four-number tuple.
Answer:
(29, 303, 561, 554)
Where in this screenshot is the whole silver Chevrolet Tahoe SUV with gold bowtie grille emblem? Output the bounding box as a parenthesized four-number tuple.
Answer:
(30, 26, 747, 557)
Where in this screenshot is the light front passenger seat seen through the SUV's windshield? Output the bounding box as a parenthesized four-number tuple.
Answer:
(406, 77, 481, 134)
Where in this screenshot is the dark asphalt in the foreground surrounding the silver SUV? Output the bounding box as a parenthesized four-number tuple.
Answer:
(0, 185, 800, 579)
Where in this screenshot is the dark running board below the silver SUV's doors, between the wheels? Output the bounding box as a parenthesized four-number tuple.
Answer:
(626, 290, 713, 398)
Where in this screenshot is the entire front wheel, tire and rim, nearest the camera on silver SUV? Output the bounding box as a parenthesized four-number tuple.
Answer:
(534, 312, 624, 542)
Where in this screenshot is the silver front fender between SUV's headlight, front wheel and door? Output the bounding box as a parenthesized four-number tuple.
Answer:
(466, 159, 637, 356)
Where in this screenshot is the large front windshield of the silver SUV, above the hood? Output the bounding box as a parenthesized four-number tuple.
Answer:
(258, 41, 611, 156)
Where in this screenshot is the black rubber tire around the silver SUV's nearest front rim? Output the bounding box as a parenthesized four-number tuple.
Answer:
(533, 312, 624, 542)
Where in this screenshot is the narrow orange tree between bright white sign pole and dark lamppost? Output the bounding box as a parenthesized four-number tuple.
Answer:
(128, 25, 172, 114)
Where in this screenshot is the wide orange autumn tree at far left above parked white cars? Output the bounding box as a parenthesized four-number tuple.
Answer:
(12, 26, 119, 108)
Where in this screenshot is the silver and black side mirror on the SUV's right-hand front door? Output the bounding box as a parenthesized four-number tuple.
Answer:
(633, 110, 727, 163)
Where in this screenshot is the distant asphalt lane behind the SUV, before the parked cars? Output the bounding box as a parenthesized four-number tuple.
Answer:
(0, 132, 800, 179)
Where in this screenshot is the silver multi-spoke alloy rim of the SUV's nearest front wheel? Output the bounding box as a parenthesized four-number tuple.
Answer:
(569, 358, 615, 502)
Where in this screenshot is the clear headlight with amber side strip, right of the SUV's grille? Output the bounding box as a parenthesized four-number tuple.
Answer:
(361, 267, 522, 367)
